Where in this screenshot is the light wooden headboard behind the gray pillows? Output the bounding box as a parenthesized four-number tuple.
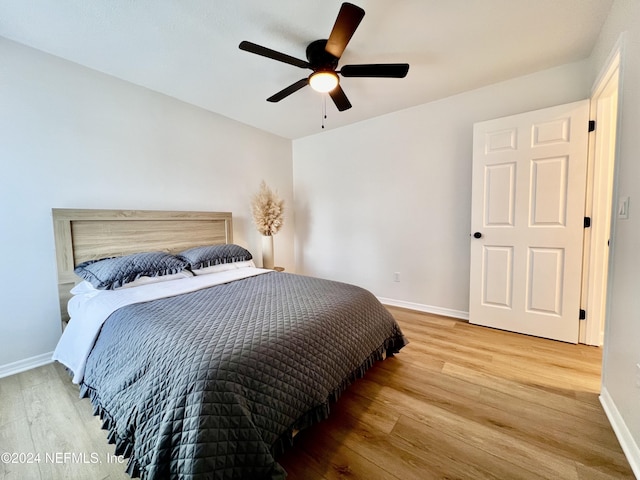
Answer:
(52, 208, 233, 325)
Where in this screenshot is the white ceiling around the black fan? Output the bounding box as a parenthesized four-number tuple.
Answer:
(0, 0, 612, 139)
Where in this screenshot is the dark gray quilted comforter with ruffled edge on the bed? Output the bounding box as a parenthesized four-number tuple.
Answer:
(81, 272, 406, 479)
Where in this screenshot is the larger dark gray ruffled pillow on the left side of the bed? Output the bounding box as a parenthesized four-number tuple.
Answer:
(74, 252, 188, 290)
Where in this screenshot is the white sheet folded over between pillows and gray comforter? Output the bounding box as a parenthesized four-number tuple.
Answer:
(53, 267, 272, 383)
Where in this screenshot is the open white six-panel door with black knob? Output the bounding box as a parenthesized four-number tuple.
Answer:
(469, 100, 589, 343)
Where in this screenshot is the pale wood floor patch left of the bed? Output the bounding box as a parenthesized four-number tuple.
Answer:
(0, 354, 130, 480)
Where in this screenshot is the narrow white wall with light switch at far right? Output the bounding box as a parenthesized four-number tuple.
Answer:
(593, 0, 640, 472)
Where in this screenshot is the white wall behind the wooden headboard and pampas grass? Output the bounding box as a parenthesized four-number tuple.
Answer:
(0, 38, 294, 375)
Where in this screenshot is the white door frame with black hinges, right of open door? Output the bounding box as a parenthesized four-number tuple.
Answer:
(578, 37, 624, 346)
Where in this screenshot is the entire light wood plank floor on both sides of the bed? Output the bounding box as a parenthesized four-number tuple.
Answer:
(0, 308, 634, 480)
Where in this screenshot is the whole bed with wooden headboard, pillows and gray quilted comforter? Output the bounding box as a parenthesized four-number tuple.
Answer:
(53, 209, 407, 479)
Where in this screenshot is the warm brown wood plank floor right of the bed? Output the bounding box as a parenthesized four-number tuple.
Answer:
(280, 308, 634, 480)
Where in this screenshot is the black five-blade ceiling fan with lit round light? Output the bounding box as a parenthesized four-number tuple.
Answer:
(240, 2, 409, 112)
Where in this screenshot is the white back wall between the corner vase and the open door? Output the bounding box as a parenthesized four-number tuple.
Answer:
(293, 62, 592, 318)
